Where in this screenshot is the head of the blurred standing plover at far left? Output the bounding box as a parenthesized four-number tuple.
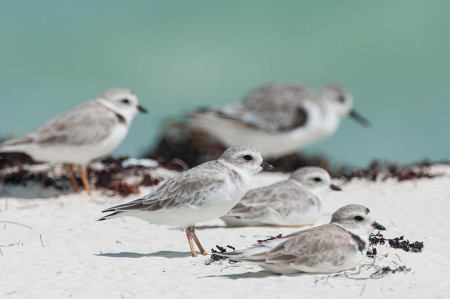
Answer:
(97, 88, 147, 121)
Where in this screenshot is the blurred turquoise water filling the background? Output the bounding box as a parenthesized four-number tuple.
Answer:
(0, 1, 450, 165)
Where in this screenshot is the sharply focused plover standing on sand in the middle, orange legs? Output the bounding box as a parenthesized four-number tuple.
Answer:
(99, 146, 274, 256)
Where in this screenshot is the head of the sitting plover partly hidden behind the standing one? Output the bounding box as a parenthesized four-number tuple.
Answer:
(289, 167, 341, 195)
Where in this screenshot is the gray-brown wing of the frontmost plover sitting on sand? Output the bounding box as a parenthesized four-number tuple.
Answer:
(233, 224, 365, 273)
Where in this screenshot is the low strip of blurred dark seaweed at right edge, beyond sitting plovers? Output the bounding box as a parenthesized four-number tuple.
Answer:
(334, 161, 439, 182)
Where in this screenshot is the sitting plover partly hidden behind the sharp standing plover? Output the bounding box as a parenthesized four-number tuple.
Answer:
(222, 167, 341, 226)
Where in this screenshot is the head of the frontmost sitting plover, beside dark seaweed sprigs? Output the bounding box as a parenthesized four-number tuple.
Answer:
(330, 204, 386, 241)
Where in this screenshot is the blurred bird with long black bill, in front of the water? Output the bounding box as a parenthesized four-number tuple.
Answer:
(191, 85, 368, 157)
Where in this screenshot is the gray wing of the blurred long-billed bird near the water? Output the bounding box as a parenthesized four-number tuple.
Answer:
(194, 85, 313, 132)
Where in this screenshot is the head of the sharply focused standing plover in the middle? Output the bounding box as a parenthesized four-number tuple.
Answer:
(219, 145, 275, 175)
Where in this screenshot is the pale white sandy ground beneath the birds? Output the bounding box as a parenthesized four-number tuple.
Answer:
(0, 167, 450, 298)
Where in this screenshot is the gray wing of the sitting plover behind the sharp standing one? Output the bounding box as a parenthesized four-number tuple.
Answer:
(224, 180, 320, 225)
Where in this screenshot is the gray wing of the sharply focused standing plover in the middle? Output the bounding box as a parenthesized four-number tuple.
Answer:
(100, 161, 232, 220)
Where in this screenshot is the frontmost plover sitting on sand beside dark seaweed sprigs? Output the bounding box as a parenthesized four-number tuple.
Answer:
(220, 204, 386, 274)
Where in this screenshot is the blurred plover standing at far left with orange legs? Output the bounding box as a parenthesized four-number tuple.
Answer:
(0, 88, 147, 195)
